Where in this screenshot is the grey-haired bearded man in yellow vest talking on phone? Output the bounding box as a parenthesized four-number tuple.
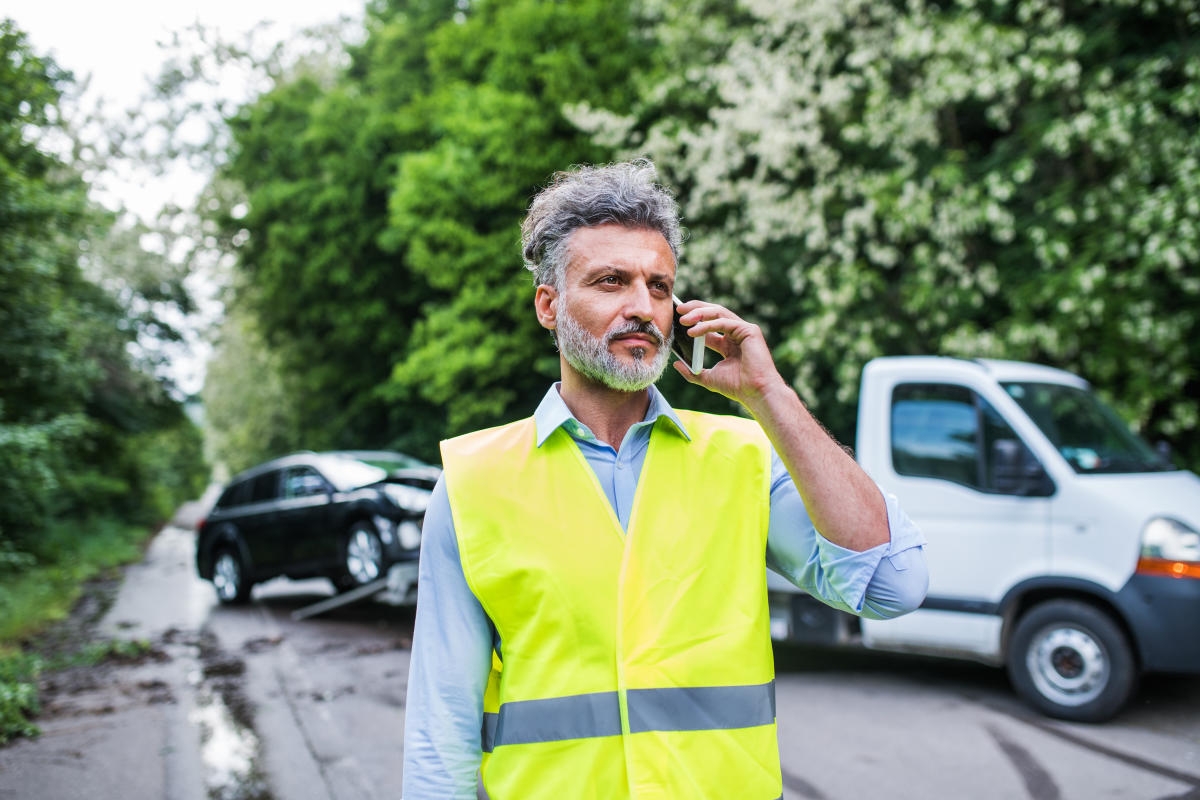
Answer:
(403, 161, 926, 800)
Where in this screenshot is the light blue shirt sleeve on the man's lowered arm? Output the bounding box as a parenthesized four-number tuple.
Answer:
(403, 479, 492, 800)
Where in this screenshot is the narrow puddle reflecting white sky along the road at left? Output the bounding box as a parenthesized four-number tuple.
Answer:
(188, 633, 274, 800)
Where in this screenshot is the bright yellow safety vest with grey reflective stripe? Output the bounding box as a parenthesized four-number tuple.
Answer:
(442, 411, 782, 800)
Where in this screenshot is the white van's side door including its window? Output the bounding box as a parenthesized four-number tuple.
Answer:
(863, 383, 1052, 660)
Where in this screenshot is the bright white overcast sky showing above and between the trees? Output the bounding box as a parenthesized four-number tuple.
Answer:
(9, 0, 365, 393)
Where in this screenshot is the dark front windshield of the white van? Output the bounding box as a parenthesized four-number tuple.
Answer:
(1001, 381, 1175, 474)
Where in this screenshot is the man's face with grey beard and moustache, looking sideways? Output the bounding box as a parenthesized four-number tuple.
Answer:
(556, 224, 676, 391)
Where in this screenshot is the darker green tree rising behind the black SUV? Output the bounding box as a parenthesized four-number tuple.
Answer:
(206, 4, 452, 463)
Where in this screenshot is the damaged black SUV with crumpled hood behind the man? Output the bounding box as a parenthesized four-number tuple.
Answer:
(196, 451, 440, 603)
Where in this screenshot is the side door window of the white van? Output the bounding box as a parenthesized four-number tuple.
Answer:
(892, 384, 1043, 494)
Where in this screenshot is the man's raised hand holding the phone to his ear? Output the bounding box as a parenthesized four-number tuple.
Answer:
(674, 300, 788, 413)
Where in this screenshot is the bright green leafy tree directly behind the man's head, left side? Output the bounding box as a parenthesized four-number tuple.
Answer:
(384, 1, 646, 433)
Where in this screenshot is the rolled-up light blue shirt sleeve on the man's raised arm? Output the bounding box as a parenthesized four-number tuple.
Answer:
(767, 451, 929, 619)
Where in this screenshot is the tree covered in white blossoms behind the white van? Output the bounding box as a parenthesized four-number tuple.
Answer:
(574, 0, 1200, 467)
